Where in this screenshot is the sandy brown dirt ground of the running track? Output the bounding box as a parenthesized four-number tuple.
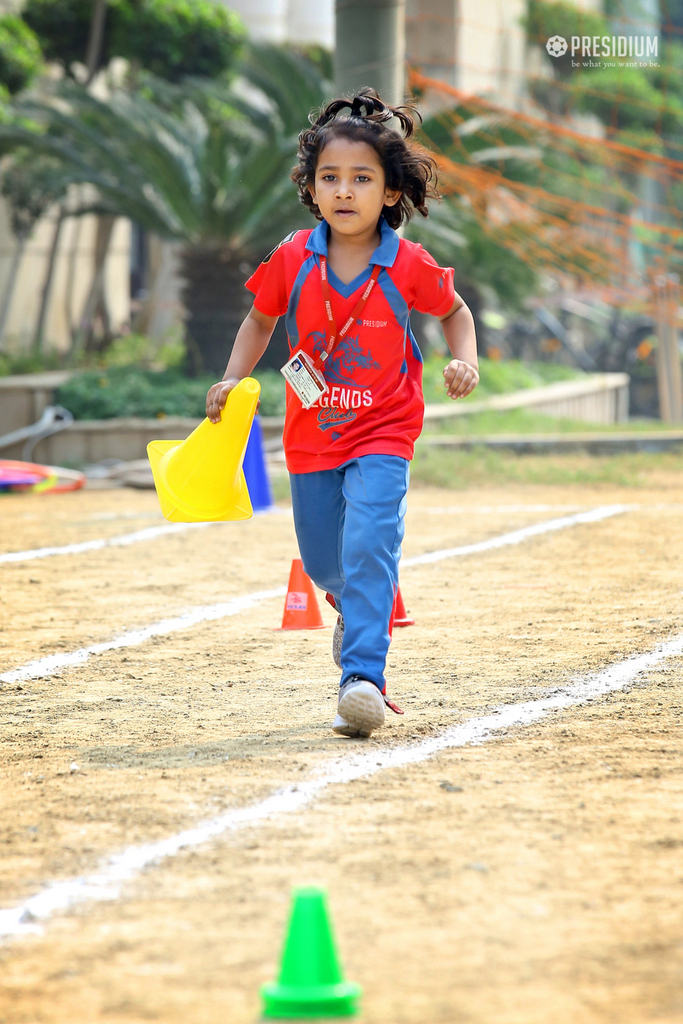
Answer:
(0, 473, 683, 1024)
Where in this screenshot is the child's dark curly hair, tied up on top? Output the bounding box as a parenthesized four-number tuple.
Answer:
(292, 88, 438, 227)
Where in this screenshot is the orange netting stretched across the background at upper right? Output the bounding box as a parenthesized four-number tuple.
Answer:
(410, 71, 683, 309)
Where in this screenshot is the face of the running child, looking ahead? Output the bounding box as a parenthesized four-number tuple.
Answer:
(308, 138, 400, 237)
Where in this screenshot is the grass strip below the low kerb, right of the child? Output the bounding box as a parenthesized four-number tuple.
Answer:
(411, 446, 683, 490)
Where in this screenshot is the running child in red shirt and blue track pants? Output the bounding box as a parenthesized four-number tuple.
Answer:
(207, 89, 479, 736)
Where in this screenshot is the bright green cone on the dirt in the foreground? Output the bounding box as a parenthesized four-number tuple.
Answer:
(261, 889, 360, 1020)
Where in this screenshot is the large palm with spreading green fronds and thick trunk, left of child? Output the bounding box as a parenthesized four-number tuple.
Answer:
(0, 46, 326, 373)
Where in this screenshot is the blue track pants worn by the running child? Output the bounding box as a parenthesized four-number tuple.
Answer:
(290, 455, 409, 691)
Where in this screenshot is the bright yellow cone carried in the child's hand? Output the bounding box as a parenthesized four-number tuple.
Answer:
(147, 377, 261, 522)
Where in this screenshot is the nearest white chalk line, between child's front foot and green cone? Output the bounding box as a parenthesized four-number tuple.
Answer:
(0, 635, 683, 939)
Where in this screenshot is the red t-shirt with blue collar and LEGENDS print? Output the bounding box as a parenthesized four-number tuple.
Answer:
(247, 218, 456, 473)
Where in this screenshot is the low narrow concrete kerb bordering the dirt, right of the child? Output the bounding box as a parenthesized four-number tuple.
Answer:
(418, 430, 683, 455)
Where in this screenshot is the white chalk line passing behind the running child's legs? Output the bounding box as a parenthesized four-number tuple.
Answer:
(0, 505, 629, 683)
